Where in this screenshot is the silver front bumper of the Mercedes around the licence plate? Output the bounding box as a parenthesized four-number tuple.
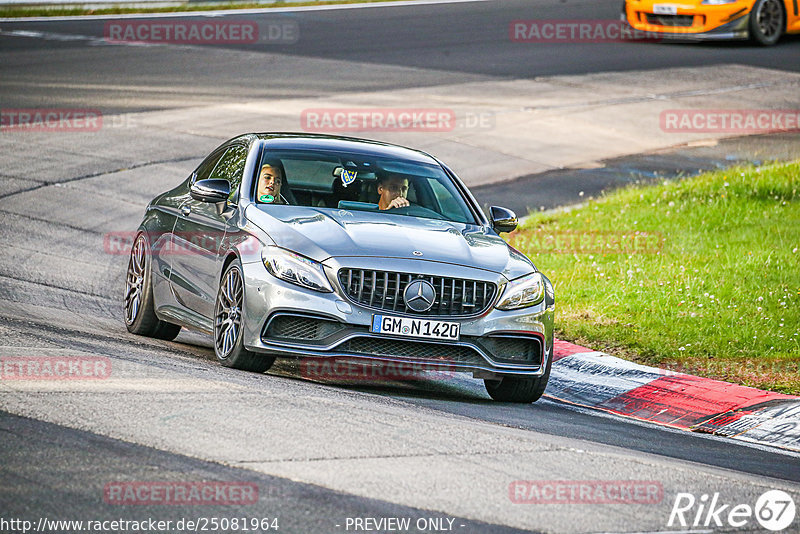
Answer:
(242, 258, 553, 377)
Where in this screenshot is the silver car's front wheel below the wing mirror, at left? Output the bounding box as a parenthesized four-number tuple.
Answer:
(214, 260, 275, 373)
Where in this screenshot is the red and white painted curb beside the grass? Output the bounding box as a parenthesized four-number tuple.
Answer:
(546, 340, 800, 451)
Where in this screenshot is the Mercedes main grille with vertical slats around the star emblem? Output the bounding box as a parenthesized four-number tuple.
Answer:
(339, 269, 497, 316)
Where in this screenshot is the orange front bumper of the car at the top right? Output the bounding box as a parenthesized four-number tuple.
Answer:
(620, 0, 753, 41)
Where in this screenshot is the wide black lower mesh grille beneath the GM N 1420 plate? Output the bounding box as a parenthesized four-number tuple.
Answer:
(337, 337, 486, 364)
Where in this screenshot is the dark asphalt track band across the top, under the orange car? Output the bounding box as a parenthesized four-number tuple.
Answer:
(0, 0, 800, 113)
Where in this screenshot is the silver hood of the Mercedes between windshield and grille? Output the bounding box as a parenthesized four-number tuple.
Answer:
(246, 204, 533, 279)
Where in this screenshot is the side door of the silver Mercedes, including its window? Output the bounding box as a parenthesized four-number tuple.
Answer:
(170, 144, 247, 320)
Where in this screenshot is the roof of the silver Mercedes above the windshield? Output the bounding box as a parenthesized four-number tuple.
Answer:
(241, 132, 439, 165)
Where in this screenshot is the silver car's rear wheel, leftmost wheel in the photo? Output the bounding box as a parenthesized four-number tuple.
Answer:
(124, 233, 181, 341)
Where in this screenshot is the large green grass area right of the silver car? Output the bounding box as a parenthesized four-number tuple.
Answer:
(511, 162, 800, 394)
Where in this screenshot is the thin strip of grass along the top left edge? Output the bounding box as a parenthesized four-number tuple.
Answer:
(0, 0, 400, 18)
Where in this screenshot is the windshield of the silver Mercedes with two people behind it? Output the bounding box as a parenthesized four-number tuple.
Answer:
(252, 150, 476, 224)
